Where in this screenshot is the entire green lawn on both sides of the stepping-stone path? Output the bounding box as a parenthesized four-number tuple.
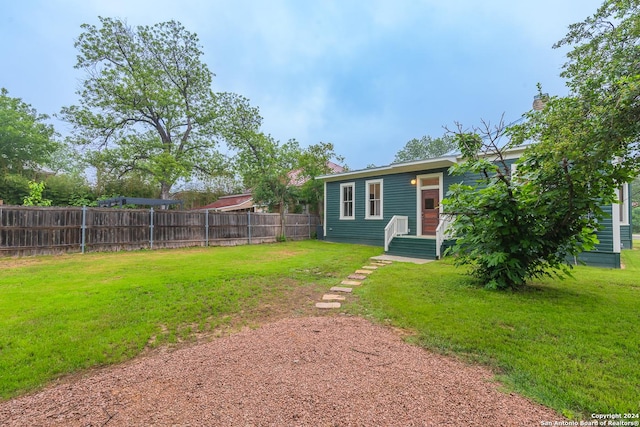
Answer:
(0, 241, 640, 418)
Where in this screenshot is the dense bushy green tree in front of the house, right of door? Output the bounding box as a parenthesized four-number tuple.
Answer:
(442, 118, 604, 289)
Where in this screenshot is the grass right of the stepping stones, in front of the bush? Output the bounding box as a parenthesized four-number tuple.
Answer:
(350, 242, 640, 421)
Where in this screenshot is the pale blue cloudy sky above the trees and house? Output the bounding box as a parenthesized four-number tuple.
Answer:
(0, 0, 601, 169)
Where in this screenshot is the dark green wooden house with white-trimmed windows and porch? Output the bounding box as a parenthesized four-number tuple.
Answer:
(319, 148, 632, 268)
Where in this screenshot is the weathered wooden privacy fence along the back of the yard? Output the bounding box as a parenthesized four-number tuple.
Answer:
(0, 206, 320, 256)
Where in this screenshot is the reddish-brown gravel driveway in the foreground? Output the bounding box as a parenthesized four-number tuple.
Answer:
(0, 316, 562, 426)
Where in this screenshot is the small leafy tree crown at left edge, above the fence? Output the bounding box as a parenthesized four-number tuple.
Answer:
(0, 88, 60, 174)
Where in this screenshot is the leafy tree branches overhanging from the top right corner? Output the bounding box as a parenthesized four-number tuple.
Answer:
(554, 0, 640, 172)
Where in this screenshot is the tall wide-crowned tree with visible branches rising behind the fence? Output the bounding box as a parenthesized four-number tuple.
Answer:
(61, 17, 255, 199)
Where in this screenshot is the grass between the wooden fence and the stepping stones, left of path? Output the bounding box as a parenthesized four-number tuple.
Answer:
(0, 241, 381, 399)
